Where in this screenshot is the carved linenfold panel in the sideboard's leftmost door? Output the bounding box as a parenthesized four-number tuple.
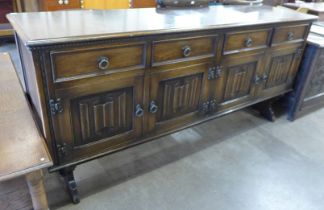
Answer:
(72, 88, 133, 145)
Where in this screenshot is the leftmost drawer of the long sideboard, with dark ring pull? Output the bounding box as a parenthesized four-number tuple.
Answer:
(51, 43, 146, 82)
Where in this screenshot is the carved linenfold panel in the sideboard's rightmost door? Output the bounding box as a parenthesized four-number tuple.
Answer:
(265, 54, 294, 88)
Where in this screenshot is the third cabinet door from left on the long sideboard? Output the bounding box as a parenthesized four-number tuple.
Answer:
(215, 52, 264, 110)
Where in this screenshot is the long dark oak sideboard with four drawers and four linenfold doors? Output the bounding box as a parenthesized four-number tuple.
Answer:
(8, 6, 316, 203)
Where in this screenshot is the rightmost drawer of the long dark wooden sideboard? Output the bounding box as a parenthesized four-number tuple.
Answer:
(272, 25, 309, 45)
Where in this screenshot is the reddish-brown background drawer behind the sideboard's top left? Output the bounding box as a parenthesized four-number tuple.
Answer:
(40, 0, 81, 11)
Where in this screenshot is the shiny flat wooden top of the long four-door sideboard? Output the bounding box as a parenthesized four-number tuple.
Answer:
(8, 6, 317, 46)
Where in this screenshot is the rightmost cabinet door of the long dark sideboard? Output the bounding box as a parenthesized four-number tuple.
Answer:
(260, 45, 303, 96)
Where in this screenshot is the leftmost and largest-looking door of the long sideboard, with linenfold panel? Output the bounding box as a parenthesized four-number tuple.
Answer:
(52, 76, 144, 162)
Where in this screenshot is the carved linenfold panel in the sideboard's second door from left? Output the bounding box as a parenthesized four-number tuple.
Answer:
(158, 74, 203, 121)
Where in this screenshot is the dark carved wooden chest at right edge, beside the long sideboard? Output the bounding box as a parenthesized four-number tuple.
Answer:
(288, 22, 324, 120)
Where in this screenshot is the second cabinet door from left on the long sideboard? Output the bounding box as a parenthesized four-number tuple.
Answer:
(148, 64, 210, 133)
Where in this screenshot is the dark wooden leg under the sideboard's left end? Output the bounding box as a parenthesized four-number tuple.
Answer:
(60, 167, 80, 204)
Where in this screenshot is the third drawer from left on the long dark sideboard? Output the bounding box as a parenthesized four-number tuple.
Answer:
(223, 29, 271, 55)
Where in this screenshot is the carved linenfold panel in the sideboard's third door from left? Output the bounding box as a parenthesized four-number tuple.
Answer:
(224, 62, 257, 101)
